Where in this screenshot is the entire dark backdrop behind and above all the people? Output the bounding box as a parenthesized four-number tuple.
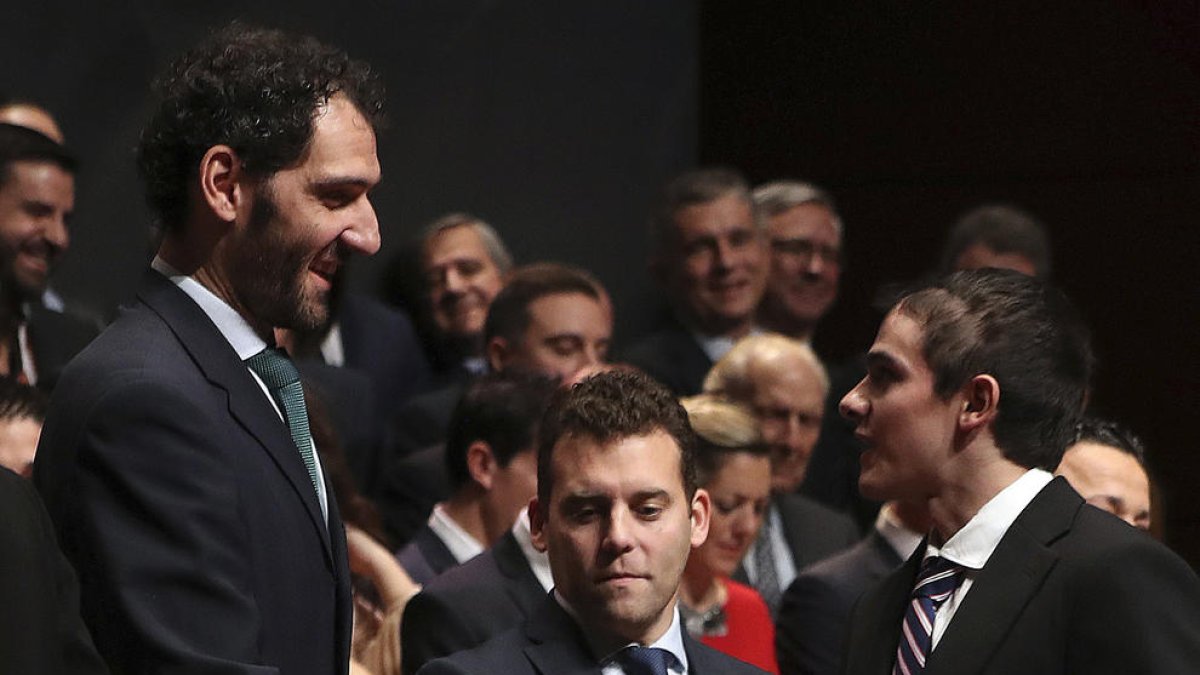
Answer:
(0, 0, 1200, 566)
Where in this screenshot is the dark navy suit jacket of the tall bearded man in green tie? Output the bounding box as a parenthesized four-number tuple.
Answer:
(34, 271, 350, 674)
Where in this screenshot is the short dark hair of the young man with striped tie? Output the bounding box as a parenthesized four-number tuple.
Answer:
(894, 269, 1092, 471)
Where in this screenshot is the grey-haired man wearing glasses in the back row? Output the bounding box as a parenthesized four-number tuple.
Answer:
(754, 180, 841, 342)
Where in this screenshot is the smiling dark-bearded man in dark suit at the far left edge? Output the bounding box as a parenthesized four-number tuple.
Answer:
(0, 124, 98, 392)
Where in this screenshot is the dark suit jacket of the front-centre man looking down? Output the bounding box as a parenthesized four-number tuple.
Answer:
(420, 596, 763, 675)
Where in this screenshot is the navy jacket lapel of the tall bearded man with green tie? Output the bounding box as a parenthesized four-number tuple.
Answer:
(138, 270, 334, 559)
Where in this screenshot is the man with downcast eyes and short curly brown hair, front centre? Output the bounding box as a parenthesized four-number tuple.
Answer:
(421, 372, 760, 675)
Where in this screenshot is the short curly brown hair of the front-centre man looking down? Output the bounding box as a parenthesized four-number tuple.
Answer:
(538, 370, 698, 504)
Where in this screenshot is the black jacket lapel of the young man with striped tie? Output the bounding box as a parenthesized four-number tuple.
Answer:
(925, 478, 1082, 675)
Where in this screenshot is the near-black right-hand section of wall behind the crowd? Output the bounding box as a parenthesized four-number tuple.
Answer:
(701, 0, 1200, 566)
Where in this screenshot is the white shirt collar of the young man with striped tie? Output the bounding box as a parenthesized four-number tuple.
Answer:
(925, 468, 1054, 569)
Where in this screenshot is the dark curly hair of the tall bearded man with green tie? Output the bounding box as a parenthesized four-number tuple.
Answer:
(138, 22, 384, 229)
